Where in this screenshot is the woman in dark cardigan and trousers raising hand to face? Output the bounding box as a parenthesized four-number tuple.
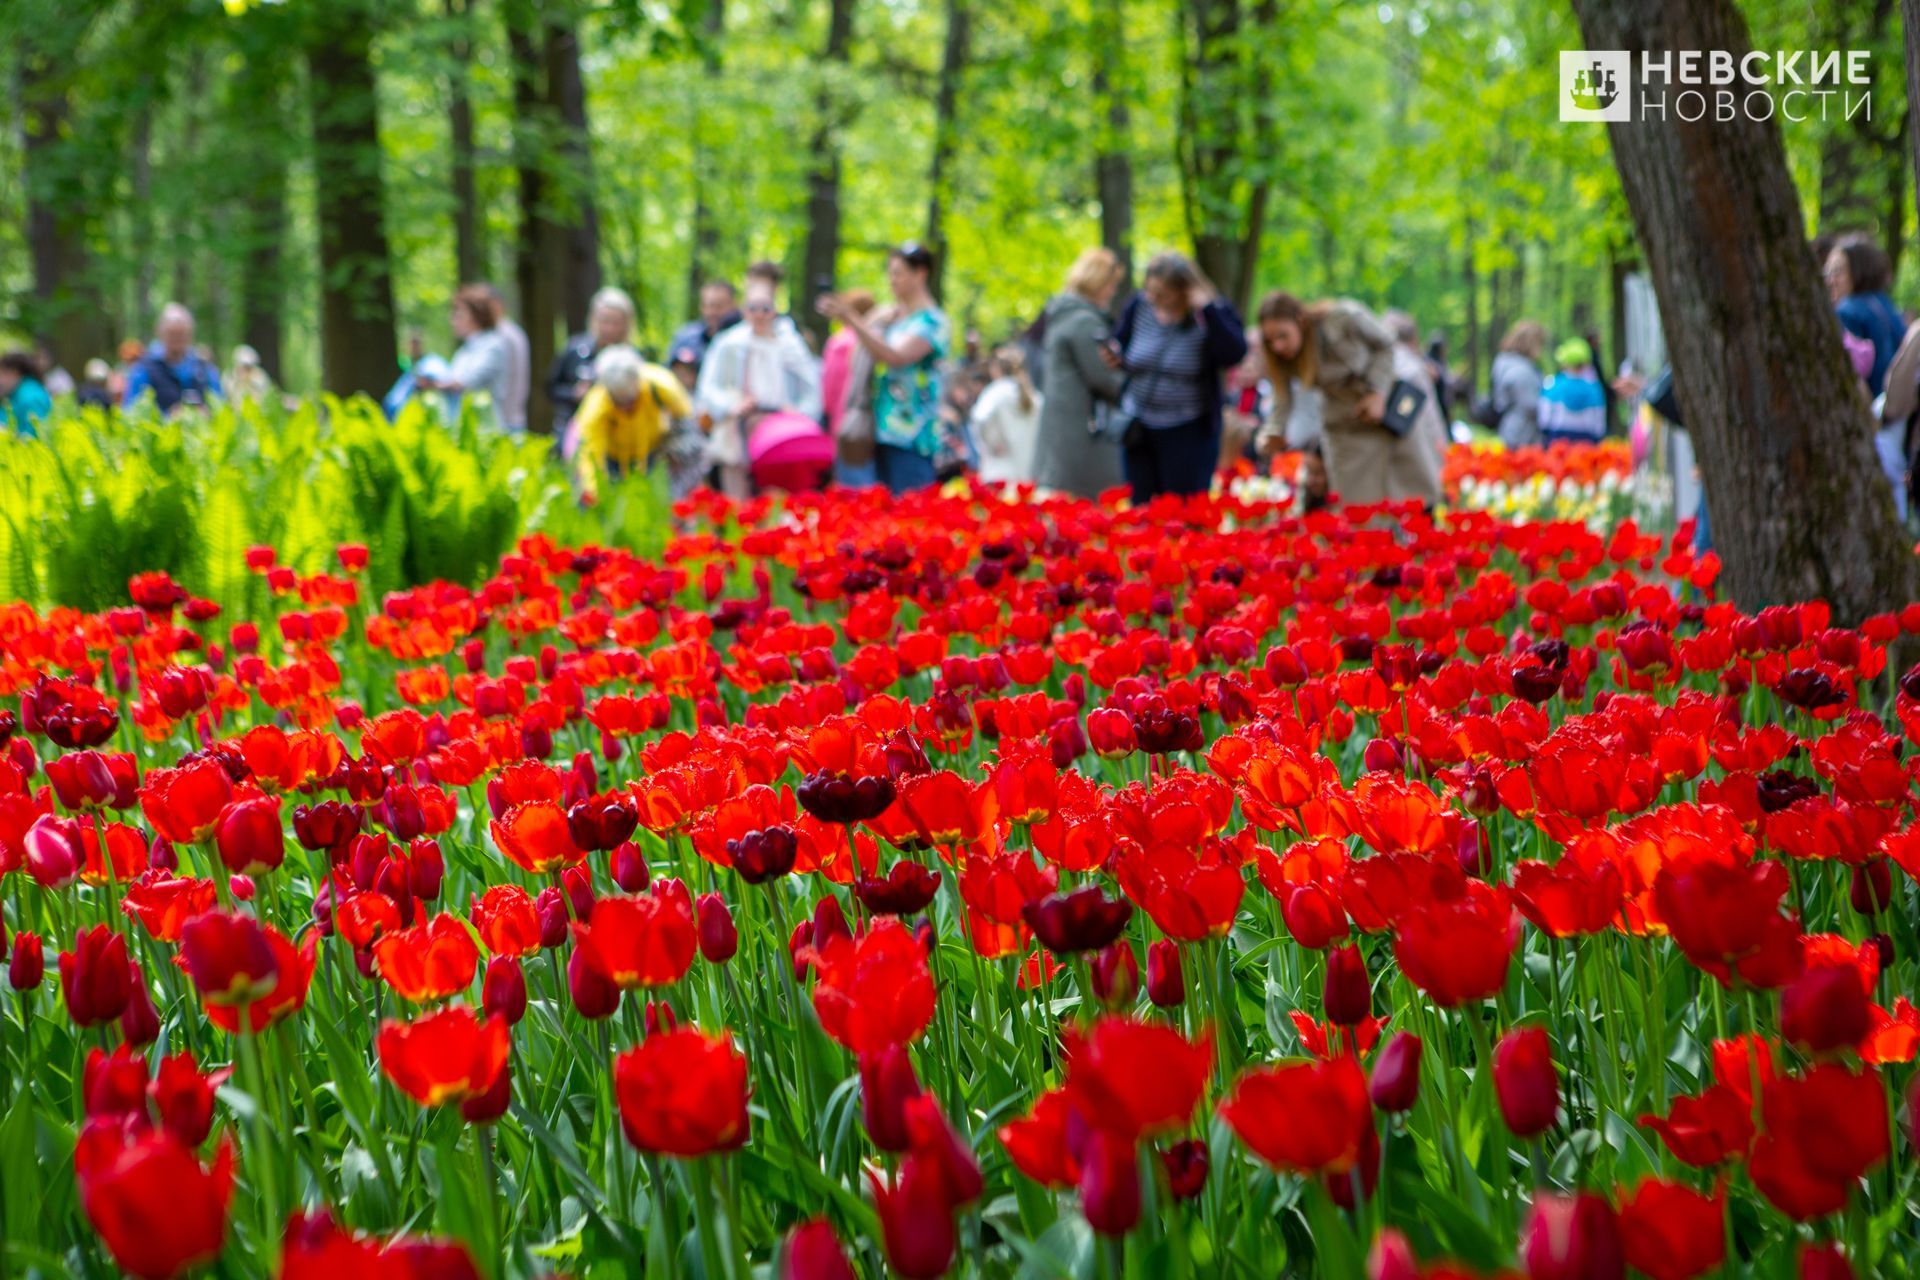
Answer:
(1114, 253, 1246, 503)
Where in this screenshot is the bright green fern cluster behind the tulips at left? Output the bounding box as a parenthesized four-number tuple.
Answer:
(0, 397, 670, 614)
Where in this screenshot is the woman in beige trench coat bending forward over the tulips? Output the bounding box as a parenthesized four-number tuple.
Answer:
(1258, 290, 1440, 505)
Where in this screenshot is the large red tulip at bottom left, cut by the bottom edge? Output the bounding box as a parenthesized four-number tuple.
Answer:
(75, 1130, 234, 1280)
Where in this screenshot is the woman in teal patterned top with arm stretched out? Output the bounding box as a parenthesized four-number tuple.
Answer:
(814, 244, 952, 493)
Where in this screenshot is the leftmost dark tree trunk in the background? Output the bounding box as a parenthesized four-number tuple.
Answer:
(15, 23, 113, 367)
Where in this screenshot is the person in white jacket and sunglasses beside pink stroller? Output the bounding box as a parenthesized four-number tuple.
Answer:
(695, 280, 820, 497)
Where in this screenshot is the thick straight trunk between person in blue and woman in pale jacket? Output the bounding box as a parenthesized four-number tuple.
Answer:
(307, 13, 397, 395)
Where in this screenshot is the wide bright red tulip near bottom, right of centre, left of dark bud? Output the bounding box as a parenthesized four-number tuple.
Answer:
(1219, 1057, 1373, 1174)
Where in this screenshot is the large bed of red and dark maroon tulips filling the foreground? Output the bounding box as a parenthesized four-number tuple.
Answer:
(0, 483, 1920, 1280)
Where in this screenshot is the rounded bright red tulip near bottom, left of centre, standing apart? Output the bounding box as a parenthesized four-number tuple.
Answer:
(612, 1027, 747, 1155)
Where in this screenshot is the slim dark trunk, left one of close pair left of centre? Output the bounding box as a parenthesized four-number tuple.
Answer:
(507, 0, 563, 432)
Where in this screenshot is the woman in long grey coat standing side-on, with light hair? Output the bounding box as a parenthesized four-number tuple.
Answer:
(1033, 249, 1127, 497)
